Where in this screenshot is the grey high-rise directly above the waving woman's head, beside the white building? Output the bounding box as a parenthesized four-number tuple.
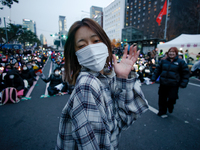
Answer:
(90, 6, 103, 28)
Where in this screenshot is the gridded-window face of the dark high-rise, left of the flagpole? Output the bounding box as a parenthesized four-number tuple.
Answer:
(124, 0, 171, 39)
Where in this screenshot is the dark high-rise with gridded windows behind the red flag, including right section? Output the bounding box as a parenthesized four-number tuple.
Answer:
(124, 0, 200, 40)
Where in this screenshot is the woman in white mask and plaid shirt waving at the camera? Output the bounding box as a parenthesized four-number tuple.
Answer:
(56, 18, 148, 150)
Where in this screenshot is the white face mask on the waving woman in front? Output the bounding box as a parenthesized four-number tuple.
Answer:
(76, 43, 109, 71)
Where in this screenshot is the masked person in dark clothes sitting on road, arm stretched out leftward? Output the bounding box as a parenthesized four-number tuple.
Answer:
(40, 68, 63, 96)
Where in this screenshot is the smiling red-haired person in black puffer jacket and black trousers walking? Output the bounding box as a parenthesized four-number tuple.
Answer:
(152, 47, 190, 118)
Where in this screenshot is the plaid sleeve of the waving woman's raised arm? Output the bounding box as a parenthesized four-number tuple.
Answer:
(112, 77, 148, 129)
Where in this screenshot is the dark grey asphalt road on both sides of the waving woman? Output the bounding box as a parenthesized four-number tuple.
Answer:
(0, 61, 200, 150)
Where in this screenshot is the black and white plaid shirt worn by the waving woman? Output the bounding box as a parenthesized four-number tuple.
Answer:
(56, 68, 148, 150)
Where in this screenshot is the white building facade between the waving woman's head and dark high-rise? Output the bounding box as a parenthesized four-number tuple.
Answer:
(103, 0, 125, 42)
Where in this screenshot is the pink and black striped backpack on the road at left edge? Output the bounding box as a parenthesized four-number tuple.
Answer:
(0, 87, 20, 105)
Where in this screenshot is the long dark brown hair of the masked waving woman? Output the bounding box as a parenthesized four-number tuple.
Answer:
(64, 18, 112, 85)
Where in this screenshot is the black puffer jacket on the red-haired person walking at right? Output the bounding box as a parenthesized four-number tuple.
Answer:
(152, 56, 190, 88)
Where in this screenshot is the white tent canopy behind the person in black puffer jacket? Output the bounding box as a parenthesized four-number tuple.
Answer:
(157, 34, 200, 59)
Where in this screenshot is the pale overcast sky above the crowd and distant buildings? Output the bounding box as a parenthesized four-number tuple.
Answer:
(0, 0, 113, 45)
